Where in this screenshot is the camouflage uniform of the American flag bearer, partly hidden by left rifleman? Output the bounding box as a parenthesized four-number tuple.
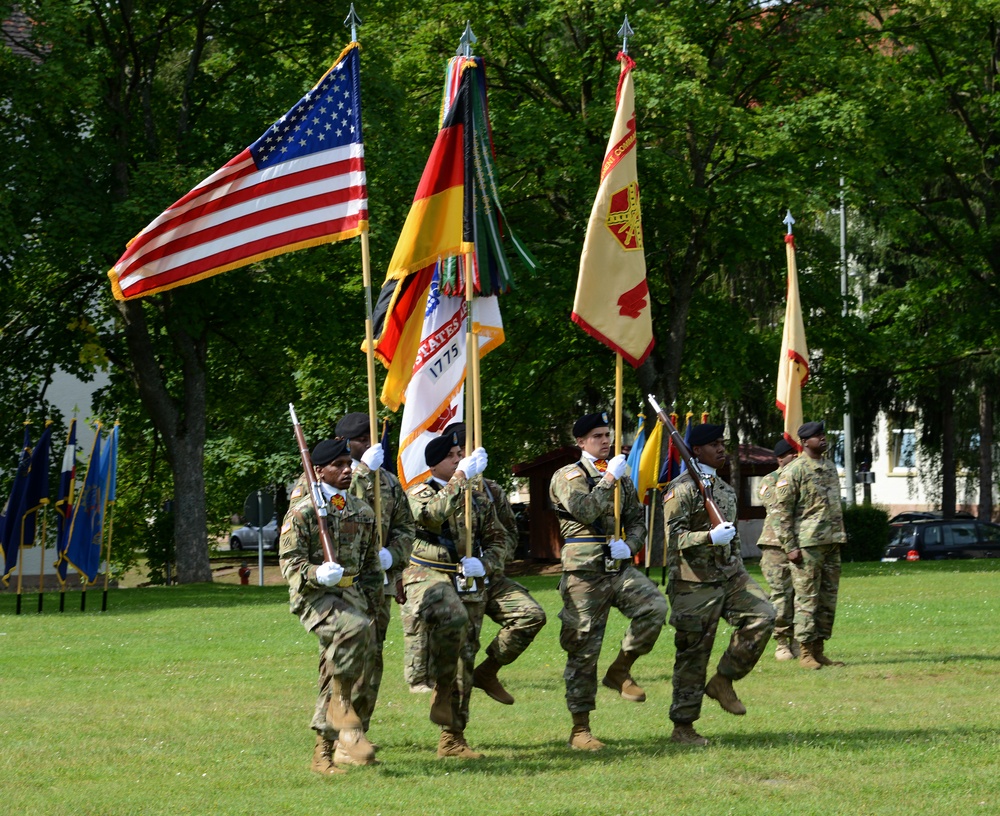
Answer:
(350, 463, 416, 728)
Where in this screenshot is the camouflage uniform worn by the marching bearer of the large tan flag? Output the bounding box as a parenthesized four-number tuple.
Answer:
(549, 456, 667, 714)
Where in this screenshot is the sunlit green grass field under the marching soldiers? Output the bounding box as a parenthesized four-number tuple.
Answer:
(0, 560, 1000, 816)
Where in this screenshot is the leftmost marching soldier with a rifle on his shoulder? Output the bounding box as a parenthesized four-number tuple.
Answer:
(279, 439, 383, 774)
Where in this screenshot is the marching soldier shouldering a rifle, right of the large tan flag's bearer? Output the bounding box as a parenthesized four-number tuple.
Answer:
(663, 423, 774, 745)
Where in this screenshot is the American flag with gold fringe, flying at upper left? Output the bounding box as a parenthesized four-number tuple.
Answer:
(108, 43, 368, 300)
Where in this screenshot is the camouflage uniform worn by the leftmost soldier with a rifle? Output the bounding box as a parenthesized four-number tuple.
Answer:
(279, 480, 384, 741)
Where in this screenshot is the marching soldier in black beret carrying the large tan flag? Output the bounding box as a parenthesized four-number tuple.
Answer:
(549, 413, 667, 751)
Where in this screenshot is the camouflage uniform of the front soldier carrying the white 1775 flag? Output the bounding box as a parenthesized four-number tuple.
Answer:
(402, 471, 506, 731)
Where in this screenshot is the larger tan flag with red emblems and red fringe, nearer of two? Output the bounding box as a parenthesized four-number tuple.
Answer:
(572, 54, 653, 367)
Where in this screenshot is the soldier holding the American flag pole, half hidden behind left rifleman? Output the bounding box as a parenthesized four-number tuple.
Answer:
(334, 413, 416, 731)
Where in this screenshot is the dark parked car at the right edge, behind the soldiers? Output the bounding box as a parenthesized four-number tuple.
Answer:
(882, 518, 1000, 561)
